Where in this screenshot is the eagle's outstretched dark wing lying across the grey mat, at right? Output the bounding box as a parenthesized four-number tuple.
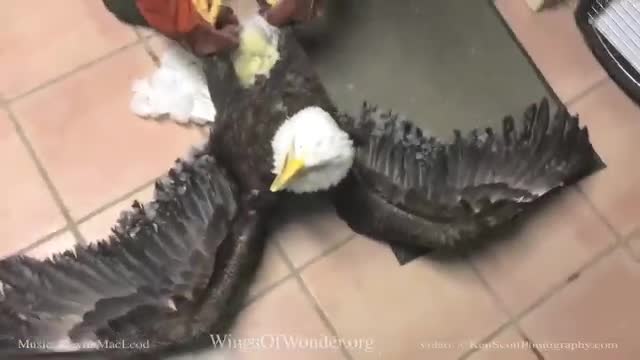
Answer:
(334, 100, 600, 255)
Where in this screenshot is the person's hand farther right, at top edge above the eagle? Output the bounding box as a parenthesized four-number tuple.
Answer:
(258, 0, 325, 27)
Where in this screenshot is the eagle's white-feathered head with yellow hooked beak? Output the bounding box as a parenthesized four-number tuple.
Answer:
(271, 106, 355, 193)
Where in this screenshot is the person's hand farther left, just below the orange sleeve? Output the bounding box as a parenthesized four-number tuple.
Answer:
(185, 6, 240, 56)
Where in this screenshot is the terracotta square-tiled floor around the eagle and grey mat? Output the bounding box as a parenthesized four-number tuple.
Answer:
(0, 0, 640, 360)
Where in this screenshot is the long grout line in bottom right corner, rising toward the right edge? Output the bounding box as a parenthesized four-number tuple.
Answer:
(458, 238, 622, 360)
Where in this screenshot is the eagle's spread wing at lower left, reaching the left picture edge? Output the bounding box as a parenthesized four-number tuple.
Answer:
(0, 147, 263, 358)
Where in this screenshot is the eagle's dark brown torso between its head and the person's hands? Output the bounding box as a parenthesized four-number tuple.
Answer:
(205, 26, 335, 190)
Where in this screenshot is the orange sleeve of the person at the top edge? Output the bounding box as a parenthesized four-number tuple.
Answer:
(136, 0, 205, 38)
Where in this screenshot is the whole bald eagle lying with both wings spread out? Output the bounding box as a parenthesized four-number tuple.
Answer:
(0, 29, 598, 359)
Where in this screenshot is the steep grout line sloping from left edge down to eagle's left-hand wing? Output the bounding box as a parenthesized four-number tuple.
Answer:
(5, 106, 86, 245)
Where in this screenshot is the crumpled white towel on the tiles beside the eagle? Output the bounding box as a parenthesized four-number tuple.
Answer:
(131, 43, 216, 124)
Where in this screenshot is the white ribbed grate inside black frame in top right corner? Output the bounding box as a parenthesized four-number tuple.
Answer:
(589, 0, 640, 79)
